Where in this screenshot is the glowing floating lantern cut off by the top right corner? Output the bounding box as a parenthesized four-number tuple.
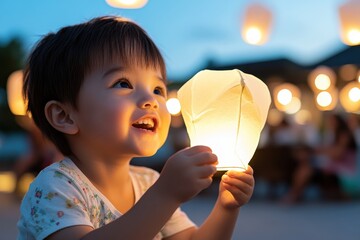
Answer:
(339, 0, 360, 46)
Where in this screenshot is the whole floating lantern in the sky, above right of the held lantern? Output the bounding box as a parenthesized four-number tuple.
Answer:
(241, 4, 272, 45)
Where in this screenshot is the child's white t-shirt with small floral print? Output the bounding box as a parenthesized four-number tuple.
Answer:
(17, 158, 195, 240)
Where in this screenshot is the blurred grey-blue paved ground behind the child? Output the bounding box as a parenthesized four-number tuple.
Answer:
(0, 189, 360, 240)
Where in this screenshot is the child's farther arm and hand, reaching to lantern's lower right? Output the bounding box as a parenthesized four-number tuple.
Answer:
(167, 166, 254, 240)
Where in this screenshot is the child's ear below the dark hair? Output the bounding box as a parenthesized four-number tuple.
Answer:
(45, 100, 79, 135)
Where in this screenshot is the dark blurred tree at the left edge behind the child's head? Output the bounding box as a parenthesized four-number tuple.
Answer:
(0, 37, 25, 132)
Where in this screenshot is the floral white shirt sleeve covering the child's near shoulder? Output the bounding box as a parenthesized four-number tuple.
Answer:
(20, 171, 93, 239)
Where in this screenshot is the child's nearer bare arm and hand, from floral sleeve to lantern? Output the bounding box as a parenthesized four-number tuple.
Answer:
(47, 146, 217, 240)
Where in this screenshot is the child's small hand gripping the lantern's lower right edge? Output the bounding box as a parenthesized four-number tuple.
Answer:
(218, 166, 255, 209)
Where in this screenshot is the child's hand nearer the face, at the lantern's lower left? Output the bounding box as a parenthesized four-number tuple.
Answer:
(157, 146, 217, 203)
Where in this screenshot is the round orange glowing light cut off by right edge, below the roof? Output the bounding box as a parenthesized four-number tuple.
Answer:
(340, 81, 360, 113)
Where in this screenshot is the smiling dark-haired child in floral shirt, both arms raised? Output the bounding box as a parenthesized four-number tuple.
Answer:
(18, 16, 254, 240)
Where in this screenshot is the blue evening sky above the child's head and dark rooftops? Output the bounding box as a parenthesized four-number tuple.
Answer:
(0, 0, 345, 78)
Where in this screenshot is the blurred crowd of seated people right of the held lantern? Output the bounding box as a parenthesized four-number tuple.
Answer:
(250, 112, 360, 204)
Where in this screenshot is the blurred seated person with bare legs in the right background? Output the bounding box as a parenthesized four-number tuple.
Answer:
(283, 114, 356, 203)
